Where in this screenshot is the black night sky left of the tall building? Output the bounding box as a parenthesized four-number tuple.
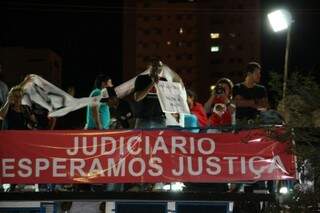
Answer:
(0, 0, 122, 96)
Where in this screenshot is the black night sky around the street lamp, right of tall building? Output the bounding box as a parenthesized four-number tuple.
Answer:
(261, 0, 320, 76)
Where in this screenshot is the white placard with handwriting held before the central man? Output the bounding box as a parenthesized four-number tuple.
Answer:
(156, 81, 189, 113)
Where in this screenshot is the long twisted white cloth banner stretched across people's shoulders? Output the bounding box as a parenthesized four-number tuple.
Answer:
(22, 65, 189, 120)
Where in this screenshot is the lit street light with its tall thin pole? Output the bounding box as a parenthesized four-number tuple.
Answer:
(268, 9, 293, 100)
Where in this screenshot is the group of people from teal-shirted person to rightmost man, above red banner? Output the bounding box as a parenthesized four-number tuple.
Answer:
(81, 60, 276, 131)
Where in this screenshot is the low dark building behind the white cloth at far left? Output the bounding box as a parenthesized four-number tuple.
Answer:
(0, 47, 62, 86)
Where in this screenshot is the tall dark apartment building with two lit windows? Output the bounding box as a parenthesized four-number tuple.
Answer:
(123, 0, 260, 101)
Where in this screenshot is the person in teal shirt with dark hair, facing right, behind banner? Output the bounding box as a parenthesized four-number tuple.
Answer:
(86, 75, 113, 129)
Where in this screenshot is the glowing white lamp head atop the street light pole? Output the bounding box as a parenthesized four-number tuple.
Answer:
(268, 10, 292, 32)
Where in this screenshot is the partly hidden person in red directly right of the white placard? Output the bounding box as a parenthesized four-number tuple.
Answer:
(187, 90, 208, 128)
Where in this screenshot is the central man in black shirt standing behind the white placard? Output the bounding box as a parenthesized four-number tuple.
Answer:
(134, 61, 166, 128)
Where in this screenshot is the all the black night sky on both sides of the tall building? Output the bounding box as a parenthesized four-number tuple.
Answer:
(0, 0, 320, 96)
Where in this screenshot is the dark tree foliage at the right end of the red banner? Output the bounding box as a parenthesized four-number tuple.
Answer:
(269, 72, 320, 212)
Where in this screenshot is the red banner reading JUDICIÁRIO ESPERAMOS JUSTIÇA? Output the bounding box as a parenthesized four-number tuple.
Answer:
(0, 129, 296, 184)
